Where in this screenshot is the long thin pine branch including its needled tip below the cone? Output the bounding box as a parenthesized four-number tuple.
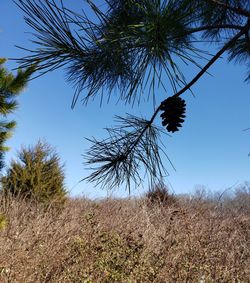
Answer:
(85, 19, 250, 192)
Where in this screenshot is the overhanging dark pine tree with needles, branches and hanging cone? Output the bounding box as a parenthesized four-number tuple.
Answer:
(15, 0, 250, 193)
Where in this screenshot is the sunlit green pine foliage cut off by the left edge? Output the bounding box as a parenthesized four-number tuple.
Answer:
(0, 58, 34, 171)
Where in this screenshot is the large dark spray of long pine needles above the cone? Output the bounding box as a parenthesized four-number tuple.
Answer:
(15, 0, 249, 107)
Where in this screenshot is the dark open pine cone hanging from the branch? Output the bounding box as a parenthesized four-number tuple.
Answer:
(161, 97, 186, 133)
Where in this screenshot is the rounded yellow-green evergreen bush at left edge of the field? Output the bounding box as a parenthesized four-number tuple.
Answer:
(1, 141, 66, 204)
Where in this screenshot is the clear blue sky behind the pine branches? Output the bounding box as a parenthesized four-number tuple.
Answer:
(0, 0, 250, 200)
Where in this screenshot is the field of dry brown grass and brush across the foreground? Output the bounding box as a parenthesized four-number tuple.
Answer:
(0, 187, 250, 283)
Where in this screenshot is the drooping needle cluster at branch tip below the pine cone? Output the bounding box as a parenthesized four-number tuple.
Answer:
(83, 115, 168, 193)
